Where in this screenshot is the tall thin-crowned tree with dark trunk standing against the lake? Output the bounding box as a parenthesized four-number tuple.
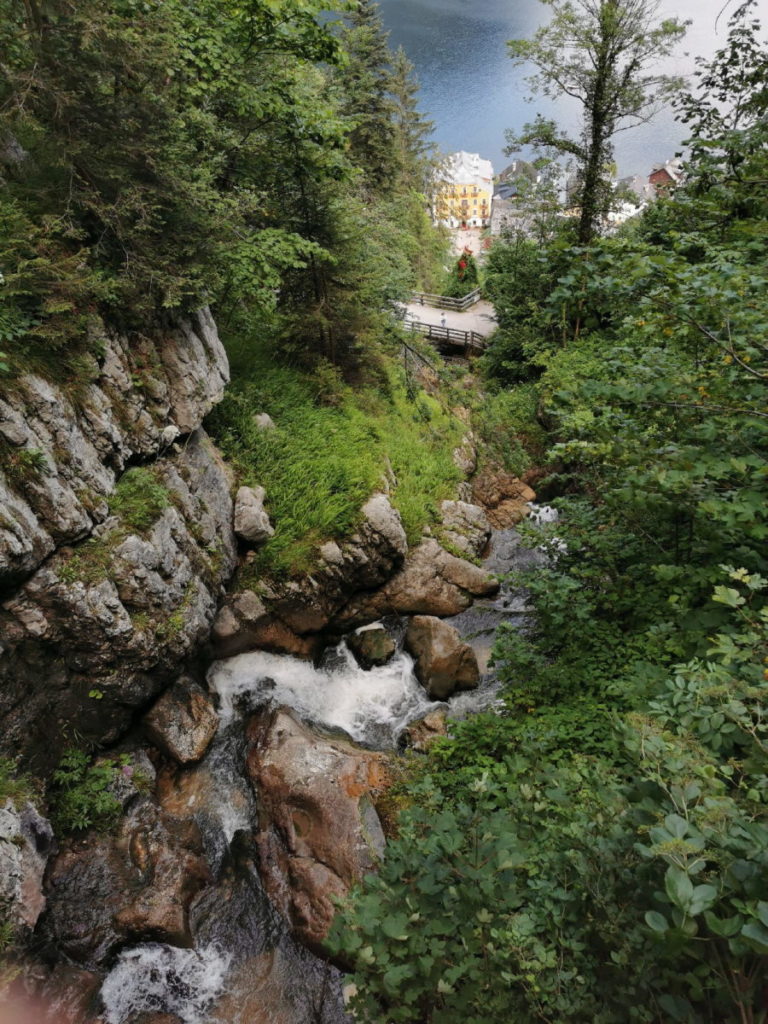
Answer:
(508, 0, 685, 245)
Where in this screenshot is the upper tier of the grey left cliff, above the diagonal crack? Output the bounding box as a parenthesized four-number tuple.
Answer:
(0, 310, 229, 590)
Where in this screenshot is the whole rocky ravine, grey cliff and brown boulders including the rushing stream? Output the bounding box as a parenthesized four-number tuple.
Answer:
(0, 314, 544, 1024)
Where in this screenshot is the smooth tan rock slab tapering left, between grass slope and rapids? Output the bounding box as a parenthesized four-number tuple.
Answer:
(334, 540, 499, 629)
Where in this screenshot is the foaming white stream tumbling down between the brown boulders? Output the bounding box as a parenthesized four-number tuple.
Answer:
(100, 506, 556, 1024)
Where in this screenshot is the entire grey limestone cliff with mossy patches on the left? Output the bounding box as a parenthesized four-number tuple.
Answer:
(0, 310, 234, 768)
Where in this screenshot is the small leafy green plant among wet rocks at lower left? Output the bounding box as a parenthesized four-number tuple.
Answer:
(49, 748, 128, 833)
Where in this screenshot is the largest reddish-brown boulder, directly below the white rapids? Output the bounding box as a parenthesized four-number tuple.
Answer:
(248, 711, 386, 950)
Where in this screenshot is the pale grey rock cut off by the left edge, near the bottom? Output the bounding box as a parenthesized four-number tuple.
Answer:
(0, 801, 53, 931)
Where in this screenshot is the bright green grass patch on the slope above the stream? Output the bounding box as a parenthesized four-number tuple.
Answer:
(209, 339, 464, 577)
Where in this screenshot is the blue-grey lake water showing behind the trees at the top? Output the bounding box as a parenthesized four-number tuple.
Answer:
(379, 0, 753, 175)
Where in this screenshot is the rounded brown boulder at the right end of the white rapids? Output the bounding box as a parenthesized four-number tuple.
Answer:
(406, 615, 480, 700)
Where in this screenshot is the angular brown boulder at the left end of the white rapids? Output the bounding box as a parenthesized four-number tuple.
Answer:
(144, 677, 219, 764)
